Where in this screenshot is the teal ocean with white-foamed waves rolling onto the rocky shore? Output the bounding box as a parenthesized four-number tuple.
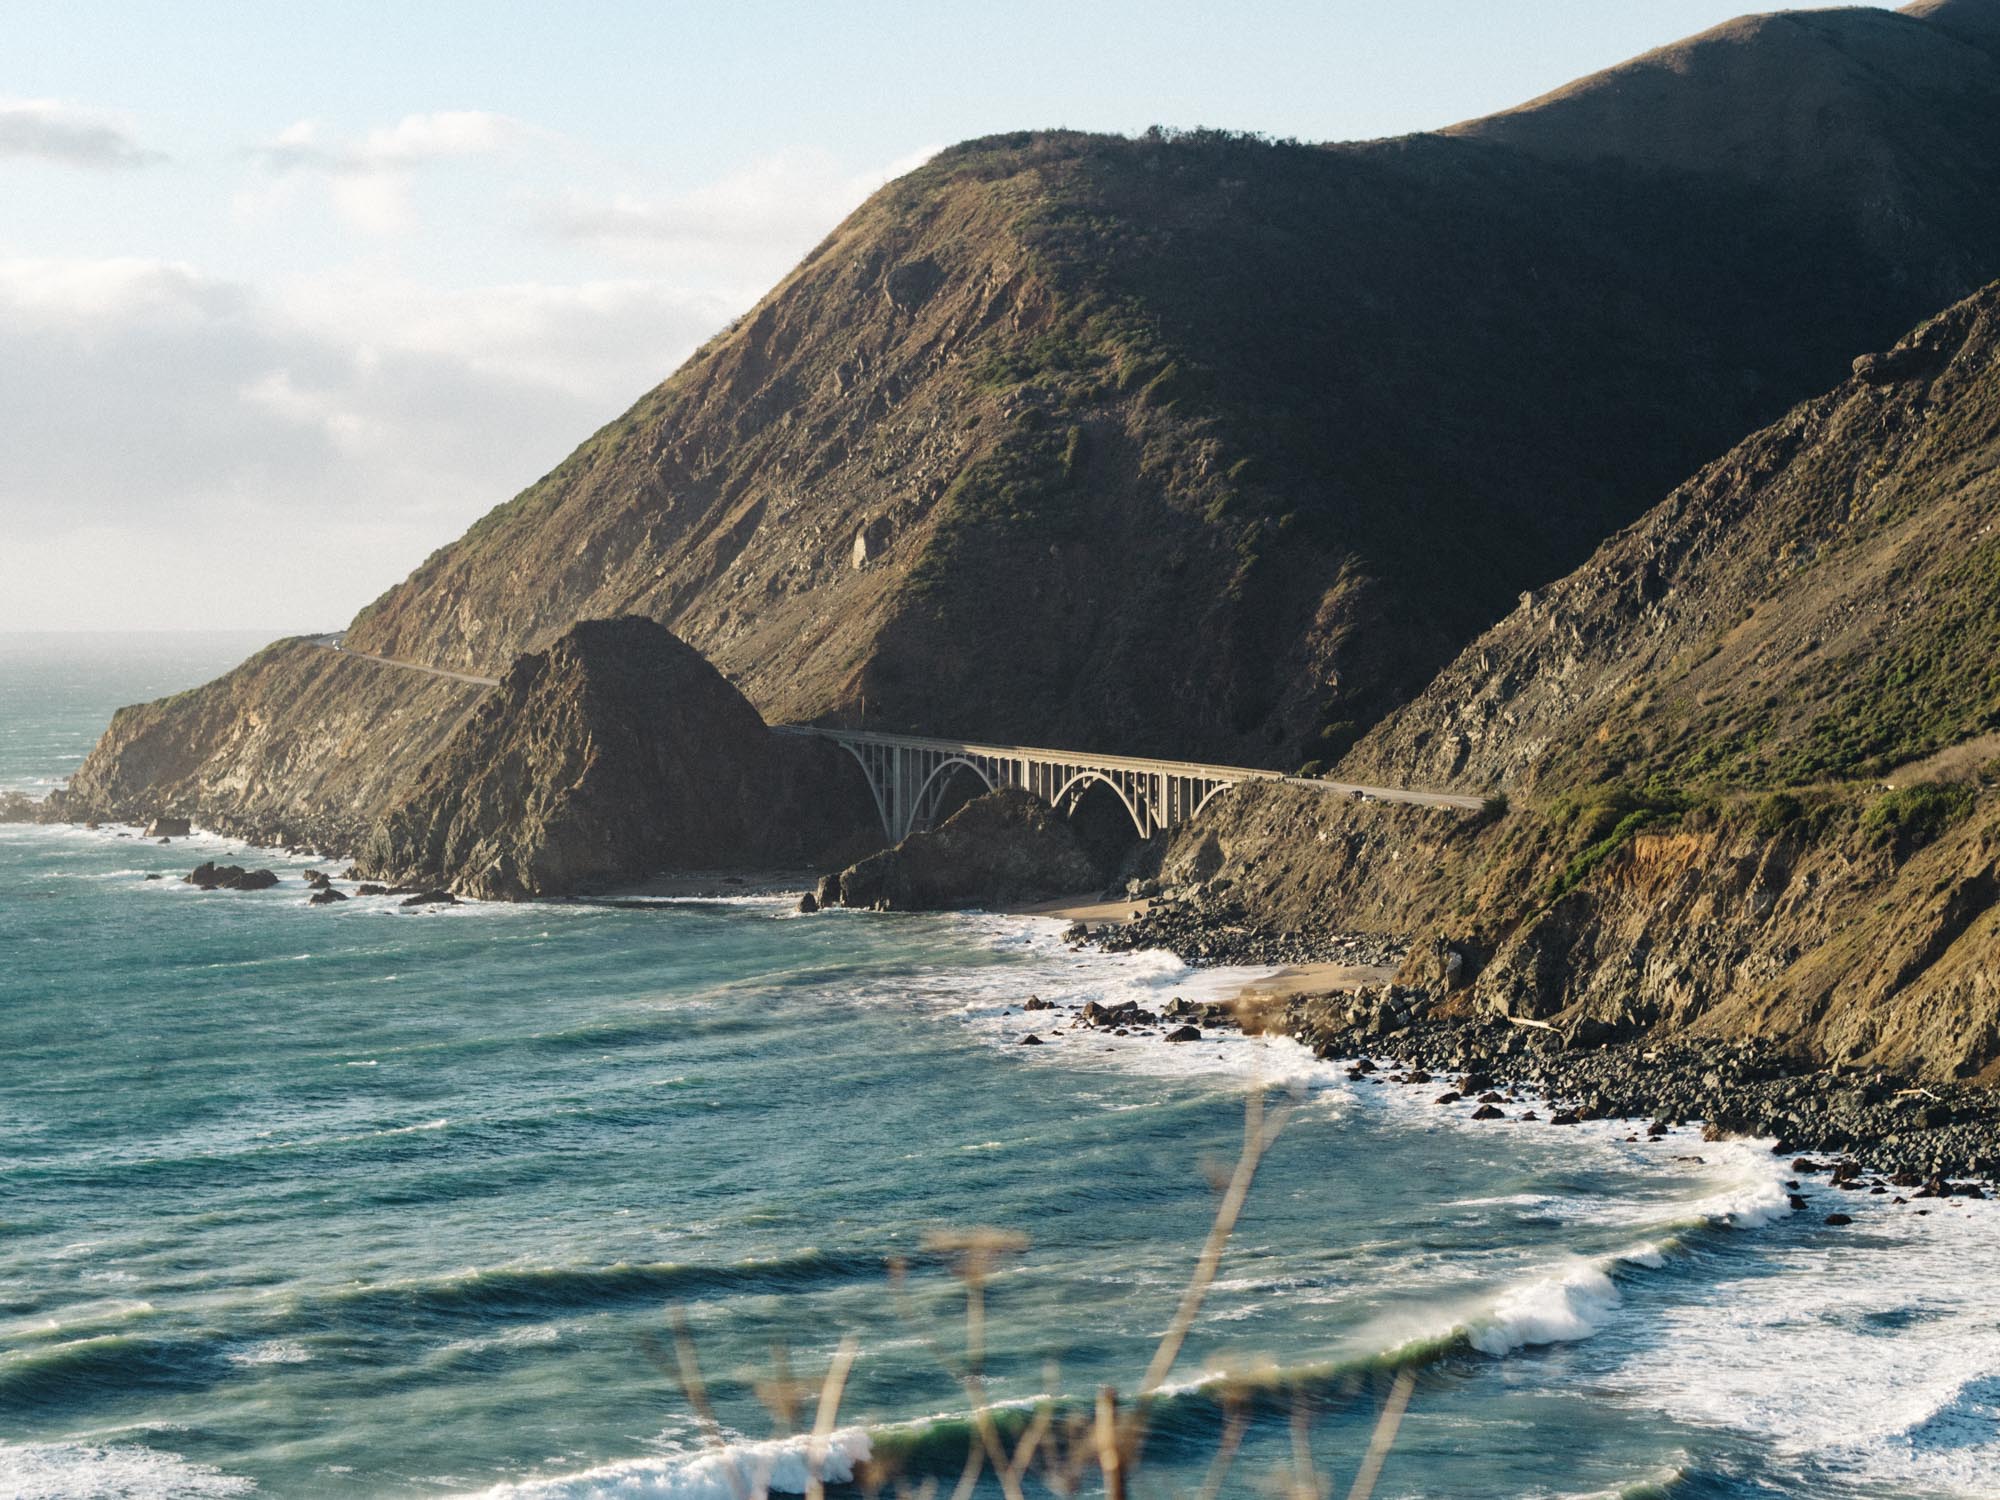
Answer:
(0, 636, 2000, 1500)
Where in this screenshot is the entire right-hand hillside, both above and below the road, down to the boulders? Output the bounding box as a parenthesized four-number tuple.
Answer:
(1168, 284, 2000, 1080)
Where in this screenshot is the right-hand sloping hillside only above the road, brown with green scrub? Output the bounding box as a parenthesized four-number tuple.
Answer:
(1342, 286, 2000, 794)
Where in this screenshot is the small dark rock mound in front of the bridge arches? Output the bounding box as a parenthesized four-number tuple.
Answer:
(834, 786, 1104, 912)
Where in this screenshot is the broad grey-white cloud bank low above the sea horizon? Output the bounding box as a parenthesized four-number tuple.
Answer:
(0, 260, 726, 628)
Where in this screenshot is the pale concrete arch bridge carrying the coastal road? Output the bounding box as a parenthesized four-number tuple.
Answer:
(772, 724, 1482, 844)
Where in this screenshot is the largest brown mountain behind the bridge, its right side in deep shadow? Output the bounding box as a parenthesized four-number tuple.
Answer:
(47, 6, 2000, 848)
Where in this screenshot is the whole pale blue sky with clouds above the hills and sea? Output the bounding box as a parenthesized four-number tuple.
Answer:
(0, 0, 1896, 634)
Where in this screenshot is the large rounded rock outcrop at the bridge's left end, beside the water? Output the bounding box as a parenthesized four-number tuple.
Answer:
(358, 616, 874, 900)
